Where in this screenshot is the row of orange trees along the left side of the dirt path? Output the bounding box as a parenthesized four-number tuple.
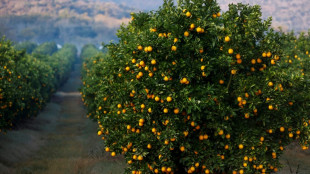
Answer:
(0, 38, 77, 131)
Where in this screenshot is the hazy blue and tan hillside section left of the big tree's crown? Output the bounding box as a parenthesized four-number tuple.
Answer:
(0, 0, 132, 48)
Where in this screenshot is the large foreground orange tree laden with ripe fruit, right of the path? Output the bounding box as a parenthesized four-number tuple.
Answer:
(81, 0, 309, 174)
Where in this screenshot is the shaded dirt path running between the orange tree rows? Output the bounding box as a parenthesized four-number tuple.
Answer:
(0, 65, 125, 174)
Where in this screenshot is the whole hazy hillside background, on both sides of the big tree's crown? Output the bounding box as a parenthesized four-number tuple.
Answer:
(0, 0, 310, 48)
